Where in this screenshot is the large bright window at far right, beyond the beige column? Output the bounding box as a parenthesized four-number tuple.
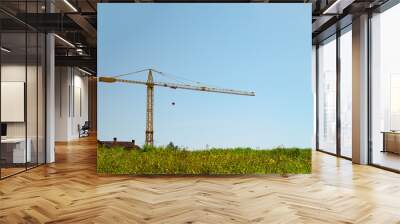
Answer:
(370, 4, 400, 170)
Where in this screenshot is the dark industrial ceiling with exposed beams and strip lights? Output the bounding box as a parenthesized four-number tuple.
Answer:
(0, 0, 394, 73)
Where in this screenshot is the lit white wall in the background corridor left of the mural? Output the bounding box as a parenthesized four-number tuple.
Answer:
(55, 67, 88, 141)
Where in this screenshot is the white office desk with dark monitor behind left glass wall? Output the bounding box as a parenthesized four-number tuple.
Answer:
(1, 138, 32, 164)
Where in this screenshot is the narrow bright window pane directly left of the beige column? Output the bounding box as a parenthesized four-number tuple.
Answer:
(339, 26, 353, 158)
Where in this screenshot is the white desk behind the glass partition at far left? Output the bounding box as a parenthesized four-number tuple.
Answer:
(1, 138, 32, 163)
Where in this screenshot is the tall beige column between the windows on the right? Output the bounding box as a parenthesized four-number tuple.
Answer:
(352, 15, 368, 164)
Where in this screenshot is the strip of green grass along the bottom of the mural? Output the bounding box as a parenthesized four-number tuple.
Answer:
(97, 145, 311, 175)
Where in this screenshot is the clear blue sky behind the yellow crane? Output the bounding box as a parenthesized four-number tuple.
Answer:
(98, 4, 313, 149)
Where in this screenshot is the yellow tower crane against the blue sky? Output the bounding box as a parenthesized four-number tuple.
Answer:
(98, 69, 255, 145)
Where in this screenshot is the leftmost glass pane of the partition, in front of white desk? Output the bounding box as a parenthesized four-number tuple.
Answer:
(0, 32, 27, 177)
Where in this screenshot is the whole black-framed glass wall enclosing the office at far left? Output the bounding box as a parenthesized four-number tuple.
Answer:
(0, 1, 46, 178)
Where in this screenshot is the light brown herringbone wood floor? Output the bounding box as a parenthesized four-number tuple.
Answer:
(0, 138, 400, 224)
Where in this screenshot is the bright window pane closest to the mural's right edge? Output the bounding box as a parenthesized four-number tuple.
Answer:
(317, 36, 336, 153)
